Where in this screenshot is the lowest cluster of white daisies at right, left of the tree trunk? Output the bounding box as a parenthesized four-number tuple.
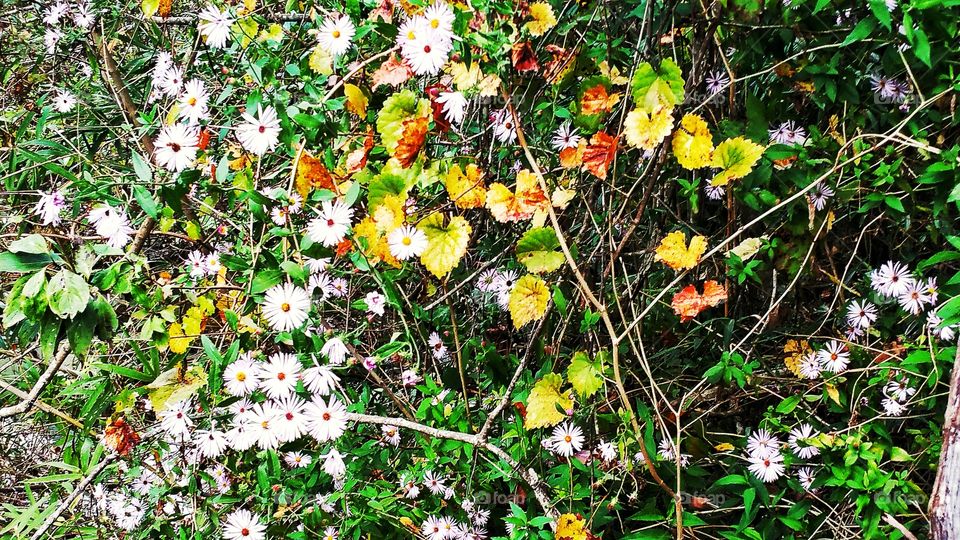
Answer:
(746, 424, 820, 491)
